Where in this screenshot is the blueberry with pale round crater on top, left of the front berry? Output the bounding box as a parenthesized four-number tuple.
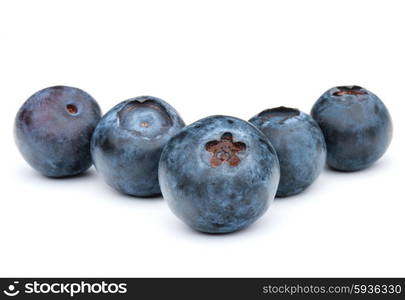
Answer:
(91, 96, 185, 197)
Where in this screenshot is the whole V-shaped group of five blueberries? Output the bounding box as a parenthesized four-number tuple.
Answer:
(14, 86, 392, 233)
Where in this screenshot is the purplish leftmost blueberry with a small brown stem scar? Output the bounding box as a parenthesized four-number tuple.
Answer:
(14, 86, 101, 177)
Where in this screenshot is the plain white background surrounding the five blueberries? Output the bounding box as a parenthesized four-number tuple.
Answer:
(0, 0, 405, 277)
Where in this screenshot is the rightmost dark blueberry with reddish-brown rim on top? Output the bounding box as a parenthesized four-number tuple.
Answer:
(311, 86, 393, 171)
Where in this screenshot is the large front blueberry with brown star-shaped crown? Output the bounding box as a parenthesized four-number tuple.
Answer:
(159, 116, 280, 233)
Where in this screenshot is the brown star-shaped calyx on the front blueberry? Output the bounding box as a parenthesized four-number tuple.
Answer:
(205, 132, 246, 167)
